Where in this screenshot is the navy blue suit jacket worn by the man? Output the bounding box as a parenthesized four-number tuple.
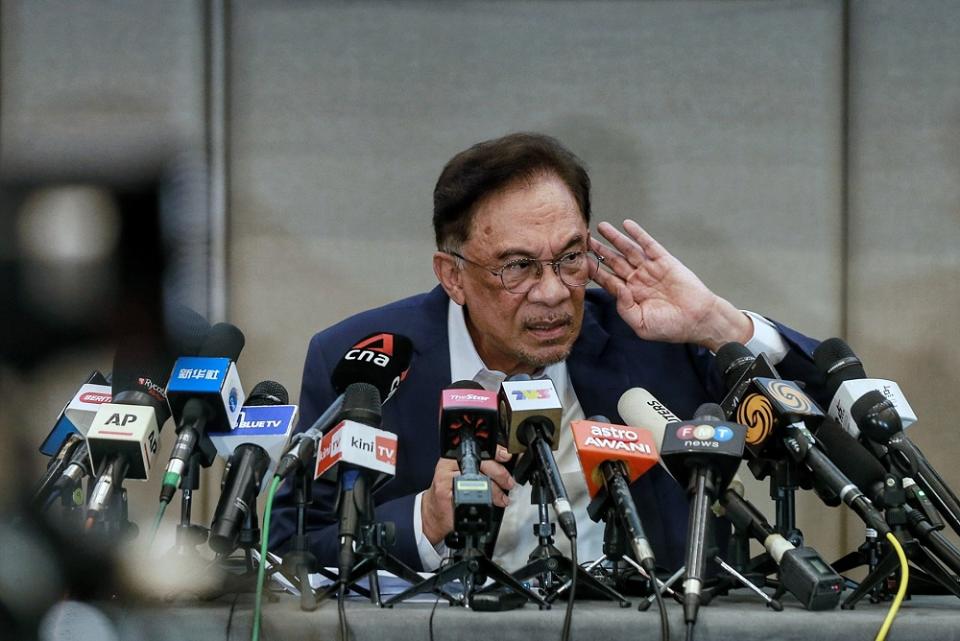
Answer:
(270, 287, 816, 569)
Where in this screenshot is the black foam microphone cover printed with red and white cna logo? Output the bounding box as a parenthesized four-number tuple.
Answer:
(330, 332, 413, 401)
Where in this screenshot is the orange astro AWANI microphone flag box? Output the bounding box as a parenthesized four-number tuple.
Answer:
(570, 420, 660, 496)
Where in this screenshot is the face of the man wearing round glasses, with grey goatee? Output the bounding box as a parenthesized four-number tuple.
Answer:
(446, 174, 589, 374)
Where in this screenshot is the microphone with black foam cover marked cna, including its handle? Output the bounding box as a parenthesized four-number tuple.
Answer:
(277, 332, 413, 478)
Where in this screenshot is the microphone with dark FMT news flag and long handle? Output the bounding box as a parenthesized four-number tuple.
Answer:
(660, 403, 746, 624)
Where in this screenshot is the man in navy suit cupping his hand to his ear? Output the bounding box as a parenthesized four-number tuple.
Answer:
(271, 134, 815, 569)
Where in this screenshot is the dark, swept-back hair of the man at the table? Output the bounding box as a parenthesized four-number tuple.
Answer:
(433, 133, 590, 250)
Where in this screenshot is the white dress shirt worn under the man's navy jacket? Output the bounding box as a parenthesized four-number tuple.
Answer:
(413, 300, 789, 571)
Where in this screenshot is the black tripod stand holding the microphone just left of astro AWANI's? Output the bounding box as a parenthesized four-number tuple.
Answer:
(502, 454, 630, 608)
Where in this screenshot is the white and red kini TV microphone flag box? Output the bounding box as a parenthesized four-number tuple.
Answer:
(313, 421, 397, 481)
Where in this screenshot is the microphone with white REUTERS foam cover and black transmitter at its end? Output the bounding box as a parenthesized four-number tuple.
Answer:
(617, 388, 842, 610)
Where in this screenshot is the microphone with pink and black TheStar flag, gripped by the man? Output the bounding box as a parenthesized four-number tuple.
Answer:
(439, 380, 500, 534)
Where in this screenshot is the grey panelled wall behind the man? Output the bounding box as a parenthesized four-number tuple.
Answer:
(0, 0, 960, 557)
